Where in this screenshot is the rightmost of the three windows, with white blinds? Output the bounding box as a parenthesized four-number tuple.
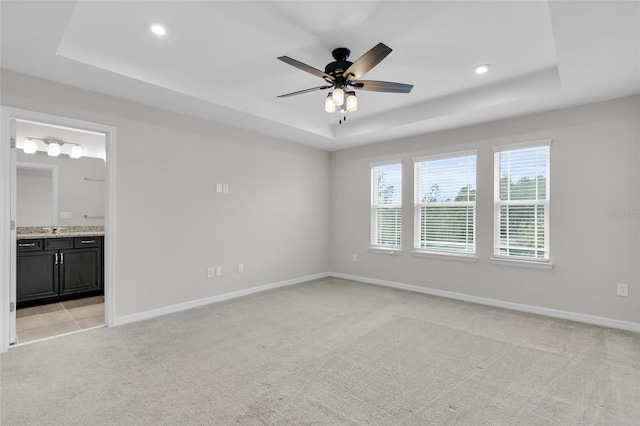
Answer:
(494, 141, 551, 262)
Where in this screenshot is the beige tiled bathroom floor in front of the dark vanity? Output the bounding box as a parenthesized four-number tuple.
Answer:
(16, 296, 104, 343)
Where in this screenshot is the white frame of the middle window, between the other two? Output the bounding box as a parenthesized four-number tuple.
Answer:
(412, 149, 478, 261)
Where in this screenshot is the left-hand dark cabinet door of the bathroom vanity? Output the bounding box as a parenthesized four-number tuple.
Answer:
(16, 250, 58, 302)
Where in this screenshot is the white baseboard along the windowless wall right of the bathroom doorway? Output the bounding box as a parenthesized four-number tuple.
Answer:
(114, 273, 329, 326)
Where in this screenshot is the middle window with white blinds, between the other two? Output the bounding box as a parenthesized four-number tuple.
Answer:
(414, 151, 476, 256)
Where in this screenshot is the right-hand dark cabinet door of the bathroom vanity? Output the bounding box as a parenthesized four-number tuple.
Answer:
(60, 248, 102, 296)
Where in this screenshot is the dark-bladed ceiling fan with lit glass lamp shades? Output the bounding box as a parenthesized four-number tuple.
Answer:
(278, 43, 413, 119)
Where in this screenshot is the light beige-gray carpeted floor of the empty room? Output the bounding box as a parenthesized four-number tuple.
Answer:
(0, 278, 640, 426)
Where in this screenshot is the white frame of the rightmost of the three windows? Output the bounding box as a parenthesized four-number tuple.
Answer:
(491, 139, 553, 269)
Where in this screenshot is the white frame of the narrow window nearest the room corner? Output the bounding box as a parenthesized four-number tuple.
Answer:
(369, 159, 404, 254)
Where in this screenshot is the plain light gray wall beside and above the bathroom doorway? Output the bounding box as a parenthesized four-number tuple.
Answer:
(1, 70, 329, 317)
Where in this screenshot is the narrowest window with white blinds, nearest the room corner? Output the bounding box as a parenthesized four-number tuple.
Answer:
(371, 161, 402, 249)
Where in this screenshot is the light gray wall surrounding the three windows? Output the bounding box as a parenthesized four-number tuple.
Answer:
(331, 96, 640, 323)
